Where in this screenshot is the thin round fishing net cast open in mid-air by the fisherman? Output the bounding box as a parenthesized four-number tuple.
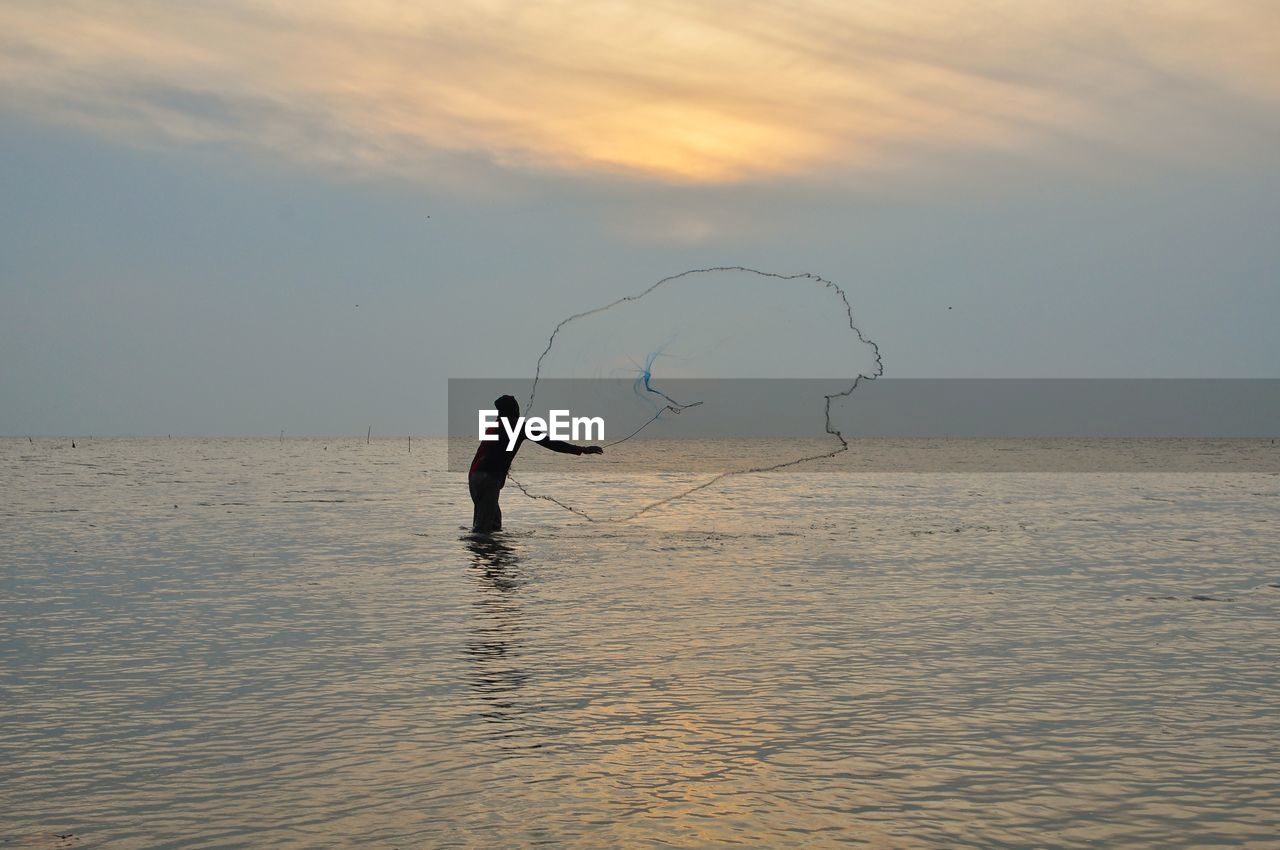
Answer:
(511, 266, 883, 521)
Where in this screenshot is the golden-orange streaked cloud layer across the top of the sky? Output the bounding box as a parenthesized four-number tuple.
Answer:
(0, 0, 1280, 183)
